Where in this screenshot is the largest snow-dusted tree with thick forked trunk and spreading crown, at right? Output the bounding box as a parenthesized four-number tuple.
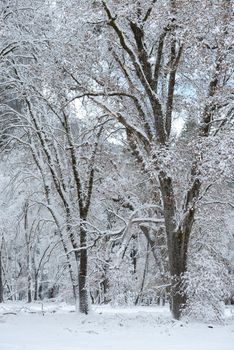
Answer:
(61, 0, 233, 318)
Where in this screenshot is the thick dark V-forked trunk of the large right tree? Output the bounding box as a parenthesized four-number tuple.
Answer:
(159, 171, 201, 319)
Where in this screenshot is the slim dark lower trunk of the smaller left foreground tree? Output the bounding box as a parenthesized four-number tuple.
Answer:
(79, 226, 89, 315)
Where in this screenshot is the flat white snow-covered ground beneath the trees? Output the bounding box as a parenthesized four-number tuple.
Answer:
(0, 303, 234, 350)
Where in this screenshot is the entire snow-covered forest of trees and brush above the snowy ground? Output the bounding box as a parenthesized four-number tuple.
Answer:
(0, 0, 234, 320)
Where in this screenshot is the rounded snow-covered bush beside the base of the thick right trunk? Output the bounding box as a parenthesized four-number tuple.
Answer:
(185, 250, 230, 322)
